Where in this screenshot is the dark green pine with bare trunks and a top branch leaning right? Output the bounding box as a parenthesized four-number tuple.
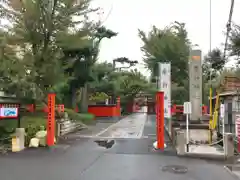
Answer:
(63, 27, 117, 111)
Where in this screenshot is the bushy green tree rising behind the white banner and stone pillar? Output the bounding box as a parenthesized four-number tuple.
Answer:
(139, 22, 190, 85)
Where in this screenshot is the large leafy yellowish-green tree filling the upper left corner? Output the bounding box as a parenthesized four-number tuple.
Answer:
(0, 0, 96, 101)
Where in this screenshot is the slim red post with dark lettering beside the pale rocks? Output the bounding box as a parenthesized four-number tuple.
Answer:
(47, 93, 56, 146)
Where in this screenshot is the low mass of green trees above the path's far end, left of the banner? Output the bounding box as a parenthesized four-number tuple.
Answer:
(90, 60, 153, 104)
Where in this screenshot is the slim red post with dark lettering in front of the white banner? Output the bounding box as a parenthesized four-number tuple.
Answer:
(156, 92, 164, 150)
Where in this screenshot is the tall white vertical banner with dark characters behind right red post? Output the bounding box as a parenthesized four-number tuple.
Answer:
(158, 63, 171, 118)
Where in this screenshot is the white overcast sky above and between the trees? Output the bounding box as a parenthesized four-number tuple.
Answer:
(91, 0, 240, 73)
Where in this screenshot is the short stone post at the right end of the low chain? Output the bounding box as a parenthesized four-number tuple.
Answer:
(223, 133, 234, 159)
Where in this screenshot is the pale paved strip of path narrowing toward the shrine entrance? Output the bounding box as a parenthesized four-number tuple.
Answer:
(96, 113, 147, 139)
